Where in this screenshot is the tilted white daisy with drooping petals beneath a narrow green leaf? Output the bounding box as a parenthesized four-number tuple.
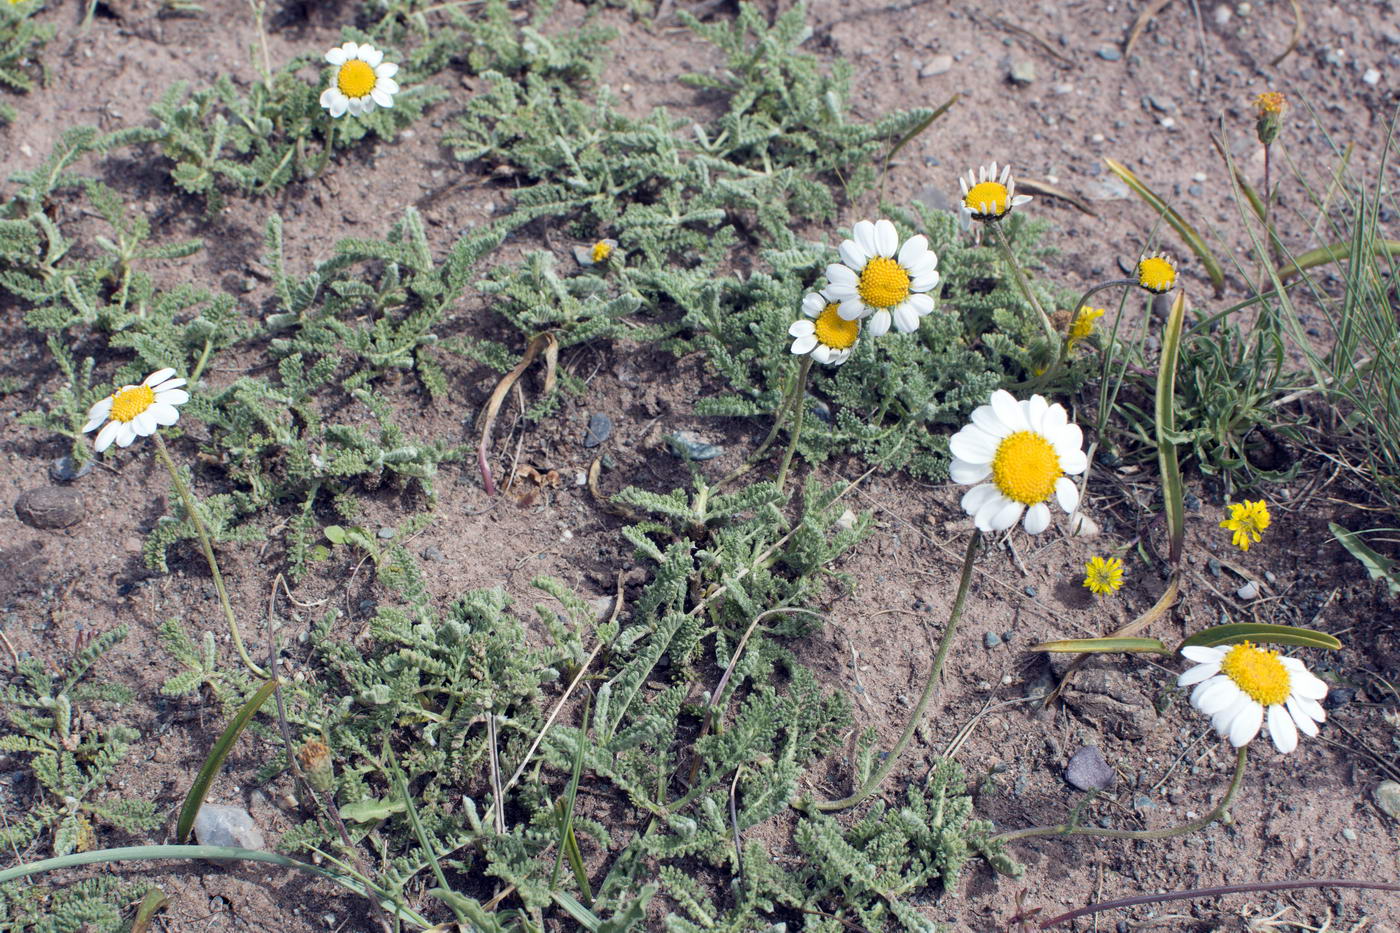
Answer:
(1176, 642, 1327, 754)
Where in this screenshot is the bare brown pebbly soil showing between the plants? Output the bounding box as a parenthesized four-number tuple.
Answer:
(0, 0, 1400, 933)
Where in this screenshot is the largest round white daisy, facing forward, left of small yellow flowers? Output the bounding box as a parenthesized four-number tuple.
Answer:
(948, 389, 1089, 535)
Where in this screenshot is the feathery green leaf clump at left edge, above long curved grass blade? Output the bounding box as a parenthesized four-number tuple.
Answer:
(0, 625, 161, 855)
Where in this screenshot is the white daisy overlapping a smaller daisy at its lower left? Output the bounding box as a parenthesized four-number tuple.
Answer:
(825, 220, 938, 336)
